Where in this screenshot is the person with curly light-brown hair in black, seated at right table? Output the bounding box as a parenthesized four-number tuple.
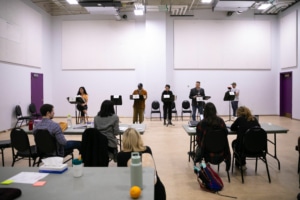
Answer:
(230, 106, 260, 170)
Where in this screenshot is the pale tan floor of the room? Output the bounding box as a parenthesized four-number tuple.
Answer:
(0, 116, 300, 200)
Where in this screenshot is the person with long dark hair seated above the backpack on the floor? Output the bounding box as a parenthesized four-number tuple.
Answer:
(194, 102, 231, 166)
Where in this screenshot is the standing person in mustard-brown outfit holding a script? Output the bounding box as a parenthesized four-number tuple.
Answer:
(132, 83, 147, 124)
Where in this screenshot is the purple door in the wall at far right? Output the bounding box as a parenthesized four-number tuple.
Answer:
(280, 72, 293, 118)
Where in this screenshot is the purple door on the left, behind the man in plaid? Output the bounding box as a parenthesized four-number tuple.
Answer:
(31, 73, 44, 113)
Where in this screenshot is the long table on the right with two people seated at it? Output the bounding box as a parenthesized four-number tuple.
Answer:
(182, 123, 289, 170)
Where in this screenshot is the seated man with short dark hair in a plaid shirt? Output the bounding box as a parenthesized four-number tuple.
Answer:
(33, 104, 81, 156)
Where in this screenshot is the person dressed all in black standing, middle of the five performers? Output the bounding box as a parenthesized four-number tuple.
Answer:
(161, 84, 174, 125)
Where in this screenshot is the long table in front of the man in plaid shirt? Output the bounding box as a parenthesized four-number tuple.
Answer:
(22, 124, 146, 149)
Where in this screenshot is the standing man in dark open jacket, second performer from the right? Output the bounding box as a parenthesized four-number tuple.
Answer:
(189, 81, 205, 121)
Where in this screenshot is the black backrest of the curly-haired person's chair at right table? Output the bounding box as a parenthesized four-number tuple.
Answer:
(242, 127, 268, 156)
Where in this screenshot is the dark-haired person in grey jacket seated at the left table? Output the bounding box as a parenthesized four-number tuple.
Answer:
(94, 100, 120, 161)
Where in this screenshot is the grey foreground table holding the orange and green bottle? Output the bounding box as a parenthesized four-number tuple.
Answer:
(0, 167, 154, 200)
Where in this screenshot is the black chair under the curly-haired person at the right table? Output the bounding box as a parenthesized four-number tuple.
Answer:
(232, 127, 271, 183)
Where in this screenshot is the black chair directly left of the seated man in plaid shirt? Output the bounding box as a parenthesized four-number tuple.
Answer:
(10, 128, 38, 167)
